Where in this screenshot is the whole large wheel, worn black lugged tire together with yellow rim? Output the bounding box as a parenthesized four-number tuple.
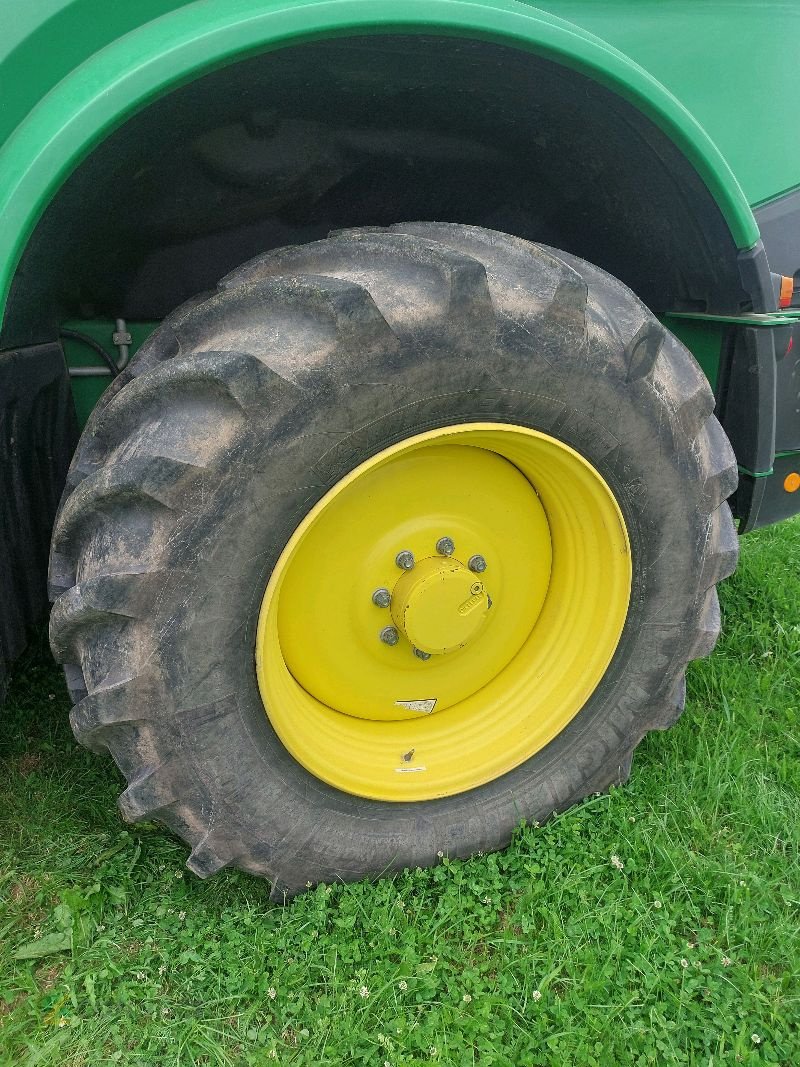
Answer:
(50, 223, 737, 899)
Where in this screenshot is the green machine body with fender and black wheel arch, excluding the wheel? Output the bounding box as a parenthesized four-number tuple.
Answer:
(0, 0, 800, 691)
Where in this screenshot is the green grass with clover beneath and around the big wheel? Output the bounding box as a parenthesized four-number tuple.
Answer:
(0, 521, 800, 1067)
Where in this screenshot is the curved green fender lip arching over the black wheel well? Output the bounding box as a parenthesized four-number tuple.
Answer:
(0, 0, 758, 332)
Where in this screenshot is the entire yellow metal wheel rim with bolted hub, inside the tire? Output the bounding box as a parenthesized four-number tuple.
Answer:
(256, 423, 631, 801)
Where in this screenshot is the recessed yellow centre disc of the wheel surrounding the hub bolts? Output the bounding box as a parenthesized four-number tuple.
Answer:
(277, 437, 550, 720)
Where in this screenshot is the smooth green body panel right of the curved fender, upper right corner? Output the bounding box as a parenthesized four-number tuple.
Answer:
(537, 0, 800, 206)
